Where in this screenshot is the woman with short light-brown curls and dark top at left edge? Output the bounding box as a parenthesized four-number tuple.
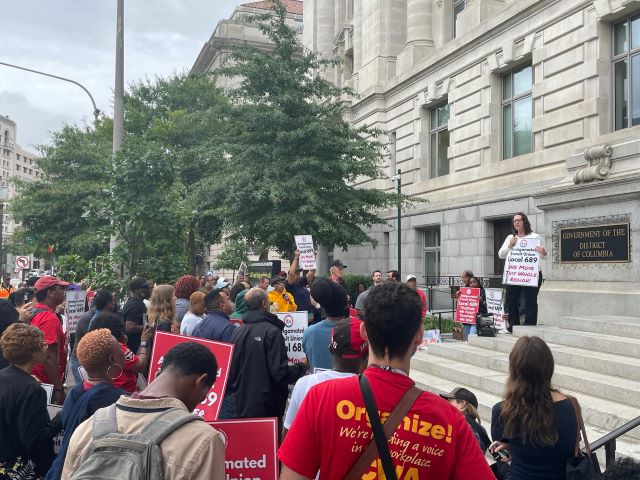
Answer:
(0, 323, 58, 480)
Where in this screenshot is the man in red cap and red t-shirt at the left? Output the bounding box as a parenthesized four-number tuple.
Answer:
(31, 275, 69, 405)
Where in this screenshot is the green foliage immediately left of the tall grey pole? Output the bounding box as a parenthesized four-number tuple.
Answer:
(10, 119, 113, 260)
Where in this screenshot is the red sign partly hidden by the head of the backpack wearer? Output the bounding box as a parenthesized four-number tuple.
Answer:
(149, 332, 233, 422)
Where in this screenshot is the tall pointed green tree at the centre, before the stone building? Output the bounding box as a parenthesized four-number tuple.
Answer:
(218, 0, 409, 258)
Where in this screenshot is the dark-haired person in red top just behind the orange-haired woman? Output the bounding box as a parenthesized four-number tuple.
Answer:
(89, 312, 153, 393)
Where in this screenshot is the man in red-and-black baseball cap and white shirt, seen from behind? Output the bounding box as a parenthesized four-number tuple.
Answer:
(283, 319, 369, 438)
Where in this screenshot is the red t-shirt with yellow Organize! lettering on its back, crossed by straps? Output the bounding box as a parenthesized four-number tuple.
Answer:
(278, 367, 495, 480)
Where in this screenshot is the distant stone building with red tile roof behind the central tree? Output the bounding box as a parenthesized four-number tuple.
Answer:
(191, 0, 303, 276)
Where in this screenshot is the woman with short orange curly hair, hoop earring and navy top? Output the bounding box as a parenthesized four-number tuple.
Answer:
(45, 328, 128, 480)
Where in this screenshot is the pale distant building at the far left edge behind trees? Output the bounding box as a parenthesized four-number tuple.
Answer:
(0, 115, 42, 272)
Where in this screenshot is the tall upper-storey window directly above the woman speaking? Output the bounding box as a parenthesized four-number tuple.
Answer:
(502, 65, 533, 159)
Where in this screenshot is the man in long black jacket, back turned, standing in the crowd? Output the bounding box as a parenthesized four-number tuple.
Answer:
(229, 288, 308, 436)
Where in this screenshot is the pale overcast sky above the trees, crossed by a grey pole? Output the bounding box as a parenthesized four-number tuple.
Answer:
(0, 0, 241, 150)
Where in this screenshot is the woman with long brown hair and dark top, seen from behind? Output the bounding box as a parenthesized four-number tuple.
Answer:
(489, 337, 578, 480)
